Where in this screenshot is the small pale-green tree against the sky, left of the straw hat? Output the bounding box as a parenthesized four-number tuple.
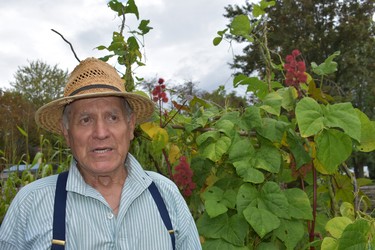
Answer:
(11, 60, 68, 108)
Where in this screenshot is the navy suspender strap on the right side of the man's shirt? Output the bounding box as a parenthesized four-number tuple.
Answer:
(148, 182, 176, 250)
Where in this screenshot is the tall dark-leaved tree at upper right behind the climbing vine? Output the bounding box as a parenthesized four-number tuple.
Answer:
(224, 0, 375, 179)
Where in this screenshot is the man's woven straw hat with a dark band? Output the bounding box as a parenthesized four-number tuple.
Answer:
(35, 58, 154, 134)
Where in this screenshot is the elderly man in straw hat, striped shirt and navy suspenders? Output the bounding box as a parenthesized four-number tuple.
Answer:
(0, 58, 201, 250)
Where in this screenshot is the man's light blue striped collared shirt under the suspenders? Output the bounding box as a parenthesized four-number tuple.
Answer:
(0, 154, 201, 250)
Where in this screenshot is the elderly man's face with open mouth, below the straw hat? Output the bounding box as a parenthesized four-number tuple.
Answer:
(63, 97, 135, 175)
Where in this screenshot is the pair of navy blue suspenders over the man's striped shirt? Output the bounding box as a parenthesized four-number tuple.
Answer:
(51, 171, 176, 250)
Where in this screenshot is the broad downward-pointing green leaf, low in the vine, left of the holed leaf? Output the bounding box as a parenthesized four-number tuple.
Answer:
(243, 206, 280, 238)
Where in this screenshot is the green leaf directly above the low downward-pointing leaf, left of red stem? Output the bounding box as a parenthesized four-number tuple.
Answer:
(258, 181, 291, 219)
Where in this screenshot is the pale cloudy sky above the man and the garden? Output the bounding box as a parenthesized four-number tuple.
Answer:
(0, 0, 253, 90)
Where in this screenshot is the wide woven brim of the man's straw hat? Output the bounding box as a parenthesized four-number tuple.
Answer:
(35, 92, 154, 134)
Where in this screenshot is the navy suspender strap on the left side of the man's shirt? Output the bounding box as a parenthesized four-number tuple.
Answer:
(51, 171, 69, 250)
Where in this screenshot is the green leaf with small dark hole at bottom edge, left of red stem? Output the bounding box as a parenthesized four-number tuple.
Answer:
(275, 220, 305, 249)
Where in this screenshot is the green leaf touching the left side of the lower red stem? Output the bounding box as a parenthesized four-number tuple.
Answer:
(284, 188, 313, 220)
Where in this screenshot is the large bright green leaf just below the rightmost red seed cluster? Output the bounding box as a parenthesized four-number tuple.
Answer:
(296, 97, 324, 137)
